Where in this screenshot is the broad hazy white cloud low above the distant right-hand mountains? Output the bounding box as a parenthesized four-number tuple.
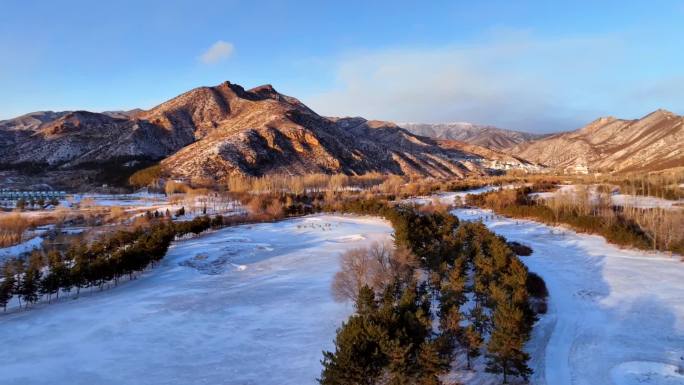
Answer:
(306, 33, 636, 132)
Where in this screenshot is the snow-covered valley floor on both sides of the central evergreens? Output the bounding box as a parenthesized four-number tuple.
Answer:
(0, 195, 684, 385)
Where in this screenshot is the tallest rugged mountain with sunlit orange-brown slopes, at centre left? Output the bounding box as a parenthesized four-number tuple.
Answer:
(154, 83, 482, 178)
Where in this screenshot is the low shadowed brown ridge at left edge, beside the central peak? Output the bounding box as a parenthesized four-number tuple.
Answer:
(0, 111, 187, 168)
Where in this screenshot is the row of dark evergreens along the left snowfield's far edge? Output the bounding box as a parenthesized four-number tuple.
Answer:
(0, 216, 223, 309)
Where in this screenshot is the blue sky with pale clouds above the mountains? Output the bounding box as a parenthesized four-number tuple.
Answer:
(0, 0, 684, 133)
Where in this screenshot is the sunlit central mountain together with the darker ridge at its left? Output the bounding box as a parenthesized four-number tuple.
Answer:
(0, 82, 510, 186)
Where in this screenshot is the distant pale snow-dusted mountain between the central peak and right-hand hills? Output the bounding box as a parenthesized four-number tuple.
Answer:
(399, 122, 543, 150)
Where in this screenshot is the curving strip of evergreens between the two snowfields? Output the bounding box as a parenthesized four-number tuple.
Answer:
(319, 199, 535, 385)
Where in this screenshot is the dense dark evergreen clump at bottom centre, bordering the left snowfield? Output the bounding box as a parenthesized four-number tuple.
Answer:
(319, 282, 440, 385)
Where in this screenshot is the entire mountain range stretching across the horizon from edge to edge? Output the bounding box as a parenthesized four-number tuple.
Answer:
(0, 82, 684, 188)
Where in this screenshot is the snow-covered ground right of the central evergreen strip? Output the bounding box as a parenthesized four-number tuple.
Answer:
(454, 209, 684, 385)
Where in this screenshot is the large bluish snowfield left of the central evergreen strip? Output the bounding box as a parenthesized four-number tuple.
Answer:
(0, 215, 392, 385)
